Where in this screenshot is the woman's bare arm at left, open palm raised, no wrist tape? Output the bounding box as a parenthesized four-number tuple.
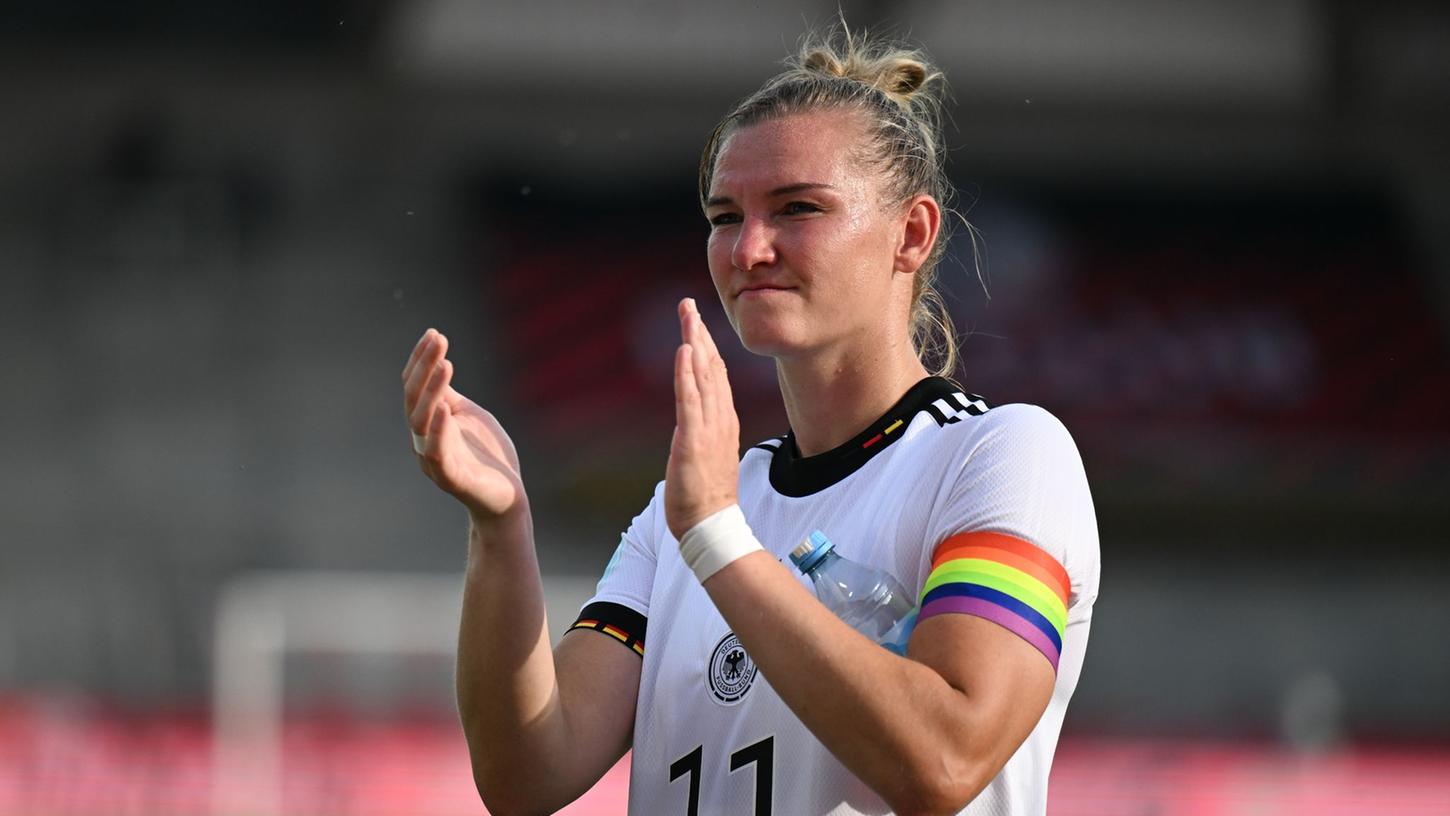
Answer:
(403, 329, 639, 816)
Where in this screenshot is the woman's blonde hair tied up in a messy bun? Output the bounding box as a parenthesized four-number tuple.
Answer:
(699, 23, 976, 377)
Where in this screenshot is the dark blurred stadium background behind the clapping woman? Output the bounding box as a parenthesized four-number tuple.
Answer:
(0, 0, 1450, 816)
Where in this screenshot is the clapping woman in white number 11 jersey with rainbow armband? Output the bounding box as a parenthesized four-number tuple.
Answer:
(403, 25, 1098, 815)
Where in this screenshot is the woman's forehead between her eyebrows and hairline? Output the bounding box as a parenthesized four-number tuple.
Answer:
(711, 110, 864, 196)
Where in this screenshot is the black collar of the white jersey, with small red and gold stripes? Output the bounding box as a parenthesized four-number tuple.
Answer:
(757, 377, 961, 497)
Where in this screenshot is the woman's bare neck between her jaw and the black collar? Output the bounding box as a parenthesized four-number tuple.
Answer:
(776, 339, 928, 457)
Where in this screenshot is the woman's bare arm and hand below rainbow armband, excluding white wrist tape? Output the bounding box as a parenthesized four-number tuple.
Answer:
(666, 303, 1056, 813)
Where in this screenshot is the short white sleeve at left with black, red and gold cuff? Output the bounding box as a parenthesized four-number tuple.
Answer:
(568, 481, 664, 657)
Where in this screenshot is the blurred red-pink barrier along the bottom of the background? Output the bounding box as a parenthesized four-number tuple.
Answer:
(0, 697, 1450, 816)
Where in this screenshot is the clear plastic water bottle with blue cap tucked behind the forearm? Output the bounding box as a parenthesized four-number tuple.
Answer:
(790, 530, 916, 655)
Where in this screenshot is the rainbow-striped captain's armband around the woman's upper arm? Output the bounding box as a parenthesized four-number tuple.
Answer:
(916, 532, 1072, 671)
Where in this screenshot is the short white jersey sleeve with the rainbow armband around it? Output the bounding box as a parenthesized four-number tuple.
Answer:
(918, 404, 1099, 670)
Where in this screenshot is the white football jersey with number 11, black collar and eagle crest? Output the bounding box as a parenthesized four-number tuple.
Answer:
(573, 378, 1098, 816)
